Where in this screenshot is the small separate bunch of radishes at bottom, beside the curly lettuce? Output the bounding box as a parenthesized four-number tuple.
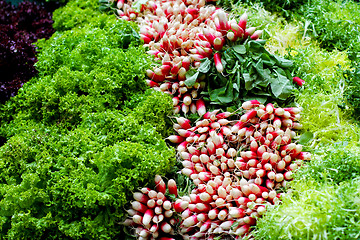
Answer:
(124, 175, 181, 240)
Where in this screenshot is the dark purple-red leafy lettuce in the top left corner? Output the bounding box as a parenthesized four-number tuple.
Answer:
(0, 1, 54, 103)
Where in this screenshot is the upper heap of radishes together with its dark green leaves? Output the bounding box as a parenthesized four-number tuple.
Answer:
(116, 0, 302, 114)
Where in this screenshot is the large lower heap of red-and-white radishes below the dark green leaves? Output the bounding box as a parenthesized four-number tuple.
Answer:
(163, 100, 310, 239)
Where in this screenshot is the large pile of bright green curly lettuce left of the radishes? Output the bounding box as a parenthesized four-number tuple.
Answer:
(0, 1, 175, 239)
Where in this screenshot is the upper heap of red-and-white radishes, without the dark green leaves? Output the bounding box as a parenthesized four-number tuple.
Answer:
(117, 0, 262, 114)
